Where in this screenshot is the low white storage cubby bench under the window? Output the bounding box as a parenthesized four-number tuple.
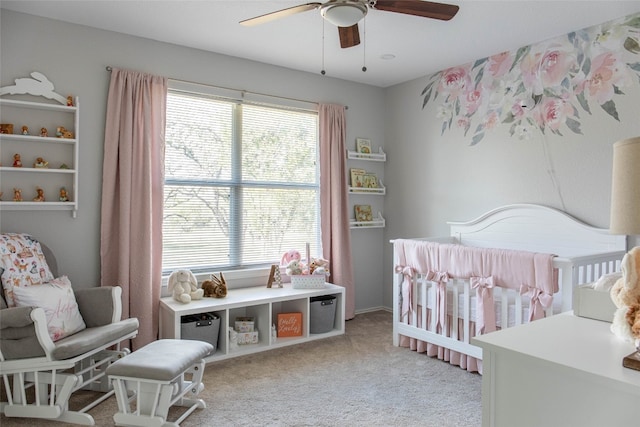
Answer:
(160, 283, 345, 362)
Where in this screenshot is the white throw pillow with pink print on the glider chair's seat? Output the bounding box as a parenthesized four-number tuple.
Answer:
(13, 276, 87, 341)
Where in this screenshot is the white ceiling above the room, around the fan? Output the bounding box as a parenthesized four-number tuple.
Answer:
(0, 0, 640, 87)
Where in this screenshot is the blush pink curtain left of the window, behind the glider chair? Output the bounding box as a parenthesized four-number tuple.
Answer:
(100, 68, 168, 350)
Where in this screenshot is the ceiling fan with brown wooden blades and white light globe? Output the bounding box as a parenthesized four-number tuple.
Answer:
(240, 0, 459, 48)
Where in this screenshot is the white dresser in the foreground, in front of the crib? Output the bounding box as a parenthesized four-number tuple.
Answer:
(471, 313, 640, 427)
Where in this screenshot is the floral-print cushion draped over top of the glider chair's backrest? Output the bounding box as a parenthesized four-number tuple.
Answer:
(0, 233, 53, 307)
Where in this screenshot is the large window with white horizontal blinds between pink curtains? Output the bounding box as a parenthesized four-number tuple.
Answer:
(162, 89, 320, 273)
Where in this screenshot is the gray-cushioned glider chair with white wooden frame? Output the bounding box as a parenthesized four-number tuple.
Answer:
(0, 235, 138, 425)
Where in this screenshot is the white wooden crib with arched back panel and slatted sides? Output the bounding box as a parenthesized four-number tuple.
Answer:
(391, 204, 627, 373)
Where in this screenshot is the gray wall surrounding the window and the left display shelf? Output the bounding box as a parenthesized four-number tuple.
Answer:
(0, 10, 384, 310)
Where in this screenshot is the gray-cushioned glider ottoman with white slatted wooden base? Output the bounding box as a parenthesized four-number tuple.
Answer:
(106, 339, 213, 427)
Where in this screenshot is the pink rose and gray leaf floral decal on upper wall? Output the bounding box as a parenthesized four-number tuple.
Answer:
(421, 13, 640, 145)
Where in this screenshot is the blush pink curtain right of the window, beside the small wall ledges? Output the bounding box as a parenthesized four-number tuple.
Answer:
(318, 104, 355, 320)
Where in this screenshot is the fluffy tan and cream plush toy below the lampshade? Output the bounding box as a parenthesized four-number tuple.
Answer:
(610, 246, 640, 341)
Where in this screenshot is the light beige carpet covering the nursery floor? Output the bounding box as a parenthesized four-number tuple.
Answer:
(0, 311, 482, 427)
